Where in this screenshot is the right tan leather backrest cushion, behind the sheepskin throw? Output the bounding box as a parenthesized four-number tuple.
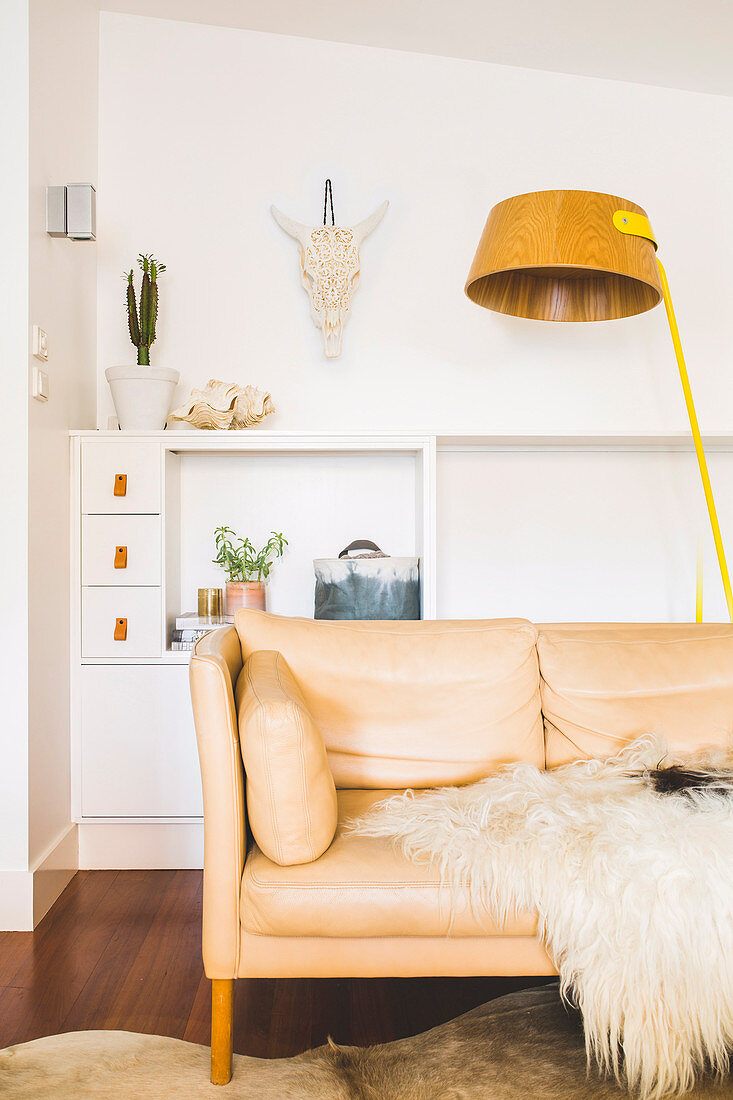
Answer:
(537, 623, 733, 768)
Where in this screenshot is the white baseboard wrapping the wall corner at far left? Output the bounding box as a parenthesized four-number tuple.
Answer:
(0, 825, 79, 932)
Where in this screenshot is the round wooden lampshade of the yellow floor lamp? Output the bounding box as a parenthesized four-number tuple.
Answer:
(466, 191, 663, 321)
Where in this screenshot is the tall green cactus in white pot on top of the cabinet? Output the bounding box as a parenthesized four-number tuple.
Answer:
(105, 252, 179, 431)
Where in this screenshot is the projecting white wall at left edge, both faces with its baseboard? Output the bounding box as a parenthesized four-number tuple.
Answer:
(0, 0, 98, 928)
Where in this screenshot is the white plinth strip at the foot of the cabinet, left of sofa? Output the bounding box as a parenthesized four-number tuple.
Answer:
(79, 822, 204, 870)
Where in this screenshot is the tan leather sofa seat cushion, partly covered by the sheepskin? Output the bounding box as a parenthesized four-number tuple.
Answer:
(241, 790, 537, 938)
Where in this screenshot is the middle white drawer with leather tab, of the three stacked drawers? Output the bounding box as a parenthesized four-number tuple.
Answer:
(81, 516, 161, 585)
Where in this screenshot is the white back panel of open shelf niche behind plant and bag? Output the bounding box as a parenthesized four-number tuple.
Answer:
(175, 454, 420, 617)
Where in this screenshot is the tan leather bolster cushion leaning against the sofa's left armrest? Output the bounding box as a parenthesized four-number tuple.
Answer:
(237, 650, 338, 866)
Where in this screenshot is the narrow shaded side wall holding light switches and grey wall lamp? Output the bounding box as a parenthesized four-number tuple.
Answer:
(29, 0, 99, 865)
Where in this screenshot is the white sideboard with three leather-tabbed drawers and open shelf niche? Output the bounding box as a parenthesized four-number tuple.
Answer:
(72, 431, 436, 867)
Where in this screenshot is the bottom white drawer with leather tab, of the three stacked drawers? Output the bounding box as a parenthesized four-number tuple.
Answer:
(81, 587, 162, 657)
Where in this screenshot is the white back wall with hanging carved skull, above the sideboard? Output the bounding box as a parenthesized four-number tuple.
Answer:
(99, 13, 733, 432)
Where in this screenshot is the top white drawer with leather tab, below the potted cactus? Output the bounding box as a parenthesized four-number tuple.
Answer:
(81, 439, 161, 515)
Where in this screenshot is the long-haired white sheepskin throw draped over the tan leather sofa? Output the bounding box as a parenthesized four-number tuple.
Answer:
(350, 737, 733, 1100)
